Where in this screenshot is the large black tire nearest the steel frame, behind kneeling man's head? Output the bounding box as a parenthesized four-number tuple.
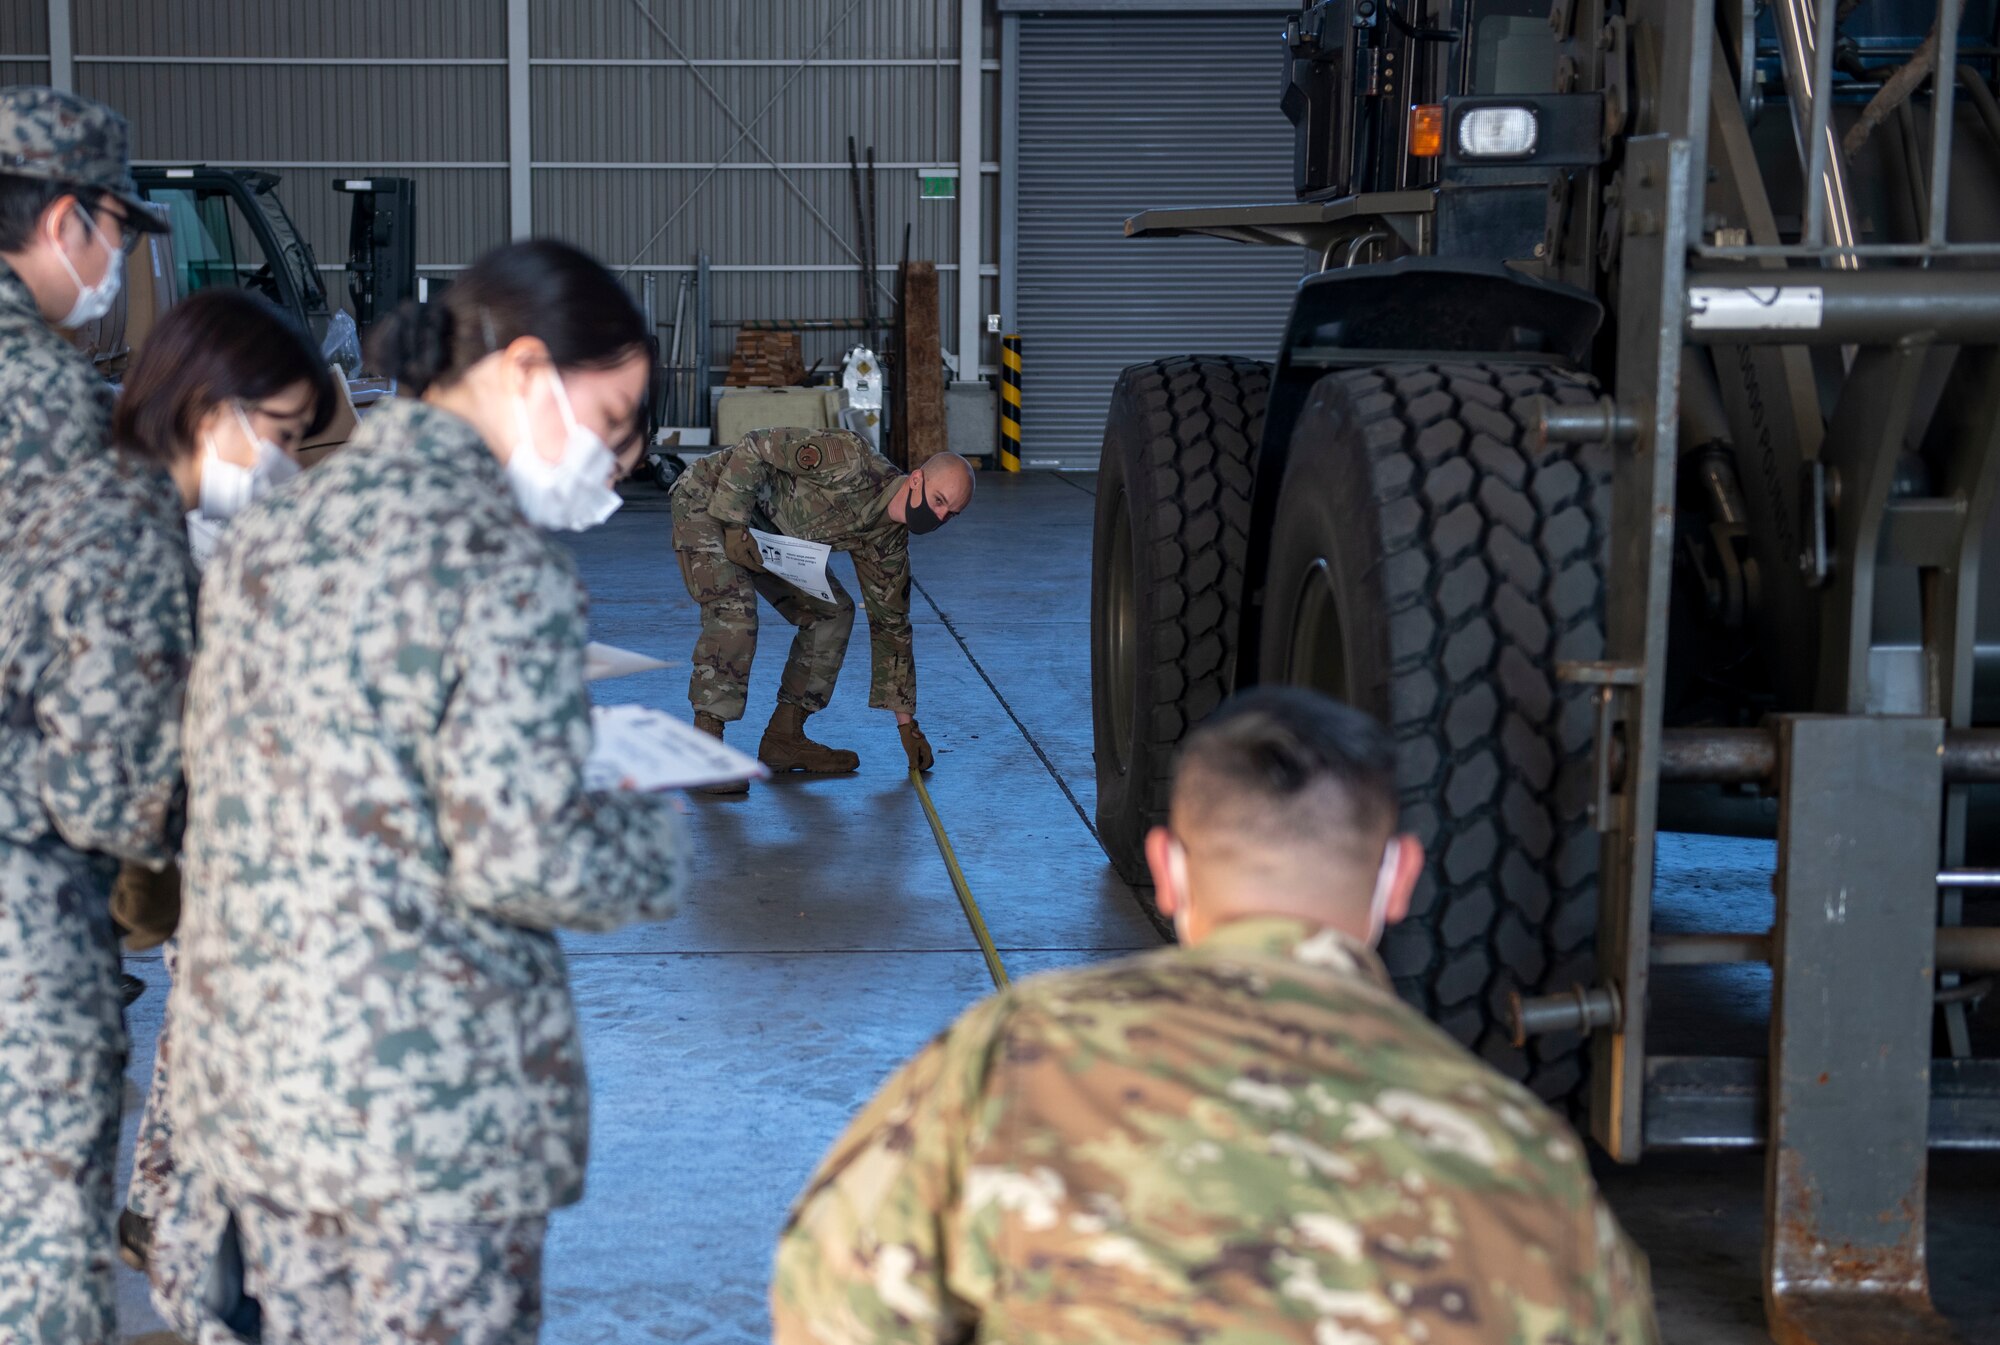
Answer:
(1258, 364, 1610, 1101)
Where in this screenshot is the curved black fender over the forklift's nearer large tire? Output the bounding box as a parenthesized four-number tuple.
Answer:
(1238, 256, 1604, 681)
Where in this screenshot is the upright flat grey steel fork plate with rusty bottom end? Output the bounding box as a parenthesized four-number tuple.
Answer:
(1764, 715, 1958, 1345)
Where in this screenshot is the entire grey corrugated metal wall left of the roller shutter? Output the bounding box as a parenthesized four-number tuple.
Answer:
(23, 0, 998, 378)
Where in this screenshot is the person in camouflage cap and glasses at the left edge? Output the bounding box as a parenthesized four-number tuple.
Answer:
(0, 88, 182, 1345)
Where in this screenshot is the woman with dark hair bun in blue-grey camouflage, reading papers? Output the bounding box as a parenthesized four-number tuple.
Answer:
(150, 240, 686, 1345)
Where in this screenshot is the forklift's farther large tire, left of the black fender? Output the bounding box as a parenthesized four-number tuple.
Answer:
(1090, 356, 1270, 885)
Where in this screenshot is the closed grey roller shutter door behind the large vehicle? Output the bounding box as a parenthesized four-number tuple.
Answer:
(1016, 14, 1304, 468)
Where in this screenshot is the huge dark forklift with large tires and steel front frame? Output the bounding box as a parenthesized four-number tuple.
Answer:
(1092, 0, 2000, 1341)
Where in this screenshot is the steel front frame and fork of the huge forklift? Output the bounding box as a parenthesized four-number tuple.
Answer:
(1568, 0, 2000, 1341)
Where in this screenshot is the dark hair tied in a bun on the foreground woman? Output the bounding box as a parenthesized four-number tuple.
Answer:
(368, 238, 648, 394)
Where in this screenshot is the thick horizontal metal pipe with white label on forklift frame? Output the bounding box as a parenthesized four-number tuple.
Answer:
(1686, 268, 2000, 346)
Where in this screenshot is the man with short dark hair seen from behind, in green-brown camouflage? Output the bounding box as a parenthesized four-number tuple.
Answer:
(772, 691, 1654, 1345)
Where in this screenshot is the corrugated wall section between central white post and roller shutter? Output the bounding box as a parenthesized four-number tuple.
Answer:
(532, 0, 998, 372)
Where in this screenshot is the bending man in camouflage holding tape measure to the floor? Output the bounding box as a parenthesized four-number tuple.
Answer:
(672, 428, 974, 793)
